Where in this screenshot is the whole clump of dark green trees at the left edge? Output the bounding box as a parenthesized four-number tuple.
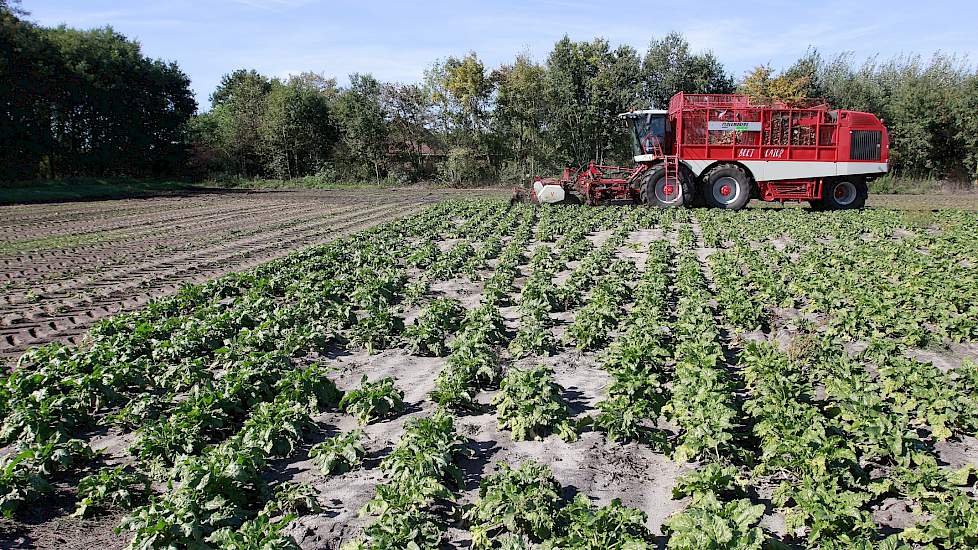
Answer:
(0, 1, 197, 180)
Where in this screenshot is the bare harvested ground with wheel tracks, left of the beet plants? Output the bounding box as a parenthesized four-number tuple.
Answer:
(0, 190, 496, 356)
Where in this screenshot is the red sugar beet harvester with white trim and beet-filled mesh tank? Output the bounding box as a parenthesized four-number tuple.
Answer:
(514, 93, 889, 210)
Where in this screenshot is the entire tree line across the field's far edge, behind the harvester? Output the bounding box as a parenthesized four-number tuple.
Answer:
(0, 0, 978, 184)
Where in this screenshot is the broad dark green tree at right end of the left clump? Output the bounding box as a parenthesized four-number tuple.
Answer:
(45, 26, 197, 175)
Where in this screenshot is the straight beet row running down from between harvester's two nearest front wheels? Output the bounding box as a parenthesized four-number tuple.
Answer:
(663, 227, 769, 550)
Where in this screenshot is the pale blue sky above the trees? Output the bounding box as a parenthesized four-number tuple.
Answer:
(22, 0, 978, 109)
